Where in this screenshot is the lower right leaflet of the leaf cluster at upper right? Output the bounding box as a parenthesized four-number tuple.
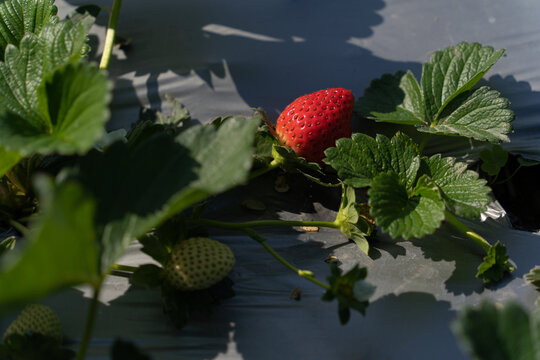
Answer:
(417, 86, 515, 142)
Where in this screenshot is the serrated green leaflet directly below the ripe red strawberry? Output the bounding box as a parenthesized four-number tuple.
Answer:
(324, 133, 420, 188)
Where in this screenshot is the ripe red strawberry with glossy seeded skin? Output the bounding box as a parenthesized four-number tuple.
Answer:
(276, 88, 354, 163)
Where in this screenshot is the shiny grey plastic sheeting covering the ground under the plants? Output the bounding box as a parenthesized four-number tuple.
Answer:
(4, 0, 540, 360)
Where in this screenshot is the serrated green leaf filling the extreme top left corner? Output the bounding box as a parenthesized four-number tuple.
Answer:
(0, 0, 58, 58)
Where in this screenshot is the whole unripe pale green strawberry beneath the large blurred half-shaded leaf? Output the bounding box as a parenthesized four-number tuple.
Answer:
(164, 237, 235, 291)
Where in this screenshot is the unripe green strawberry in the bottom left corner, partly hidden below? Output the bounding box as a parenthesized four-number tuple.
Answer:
(4, 304, 62, 342)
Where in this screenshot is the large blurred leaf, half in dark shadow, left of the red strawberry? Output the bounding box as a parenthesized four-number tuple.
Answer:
(78, 118, 258, 269)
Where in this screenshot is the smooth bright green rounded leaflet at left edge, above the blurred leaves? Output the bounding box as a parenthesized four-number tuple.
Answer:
(0, 61, 111, 155)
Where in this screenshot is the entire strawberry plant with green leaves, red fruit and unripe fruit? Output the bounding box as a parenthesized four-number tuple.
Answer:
(0, 0, 537, 359)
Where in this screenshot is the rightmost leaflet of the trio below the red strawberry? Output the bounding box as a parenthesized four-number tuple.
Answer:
(420, 154, 490, 218)
